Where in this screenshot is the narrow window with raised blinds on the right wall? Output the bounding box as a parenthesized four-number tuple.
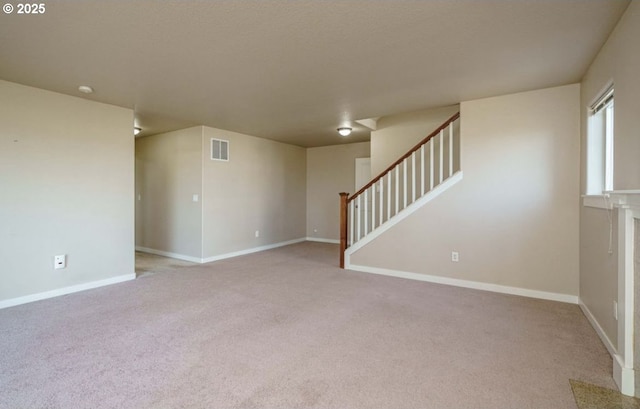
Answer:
(586, 87, 613, 195)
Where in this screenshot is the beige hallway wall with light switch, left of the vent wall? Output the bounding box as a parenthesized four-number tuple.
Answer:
(135, 126, 202, 259)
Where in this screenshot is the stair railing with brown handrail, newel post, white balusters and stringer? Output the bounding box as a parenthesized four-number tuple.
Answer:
(340, 113, 462, 268)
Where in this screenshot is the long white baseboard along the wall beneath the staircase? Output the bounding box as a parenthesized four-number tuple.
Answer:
(345, 264, 578, 304)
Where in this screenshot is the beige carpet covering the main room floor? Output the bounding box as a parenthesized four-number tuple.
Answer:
(0, 242, 615, 409)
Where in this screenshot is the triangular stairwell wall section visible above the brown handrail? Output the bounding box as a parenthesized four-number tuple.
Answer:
(371, 105, 460, 176)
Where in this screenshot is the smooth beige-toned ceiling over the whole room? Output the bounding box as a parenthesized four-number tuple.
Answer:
(0, 0, 629, 146)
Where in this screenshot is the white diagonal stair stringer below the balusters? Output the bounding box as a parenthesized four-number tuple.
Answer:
(344, 170, 463, 269)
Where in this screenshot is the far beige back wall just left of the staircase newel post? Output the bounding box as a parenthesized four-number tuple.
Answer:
(307, 142, 370, 240)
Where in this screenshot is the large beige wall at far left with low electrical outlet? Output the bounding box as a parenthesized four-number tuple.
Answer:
(0, 81, 134, 301)
